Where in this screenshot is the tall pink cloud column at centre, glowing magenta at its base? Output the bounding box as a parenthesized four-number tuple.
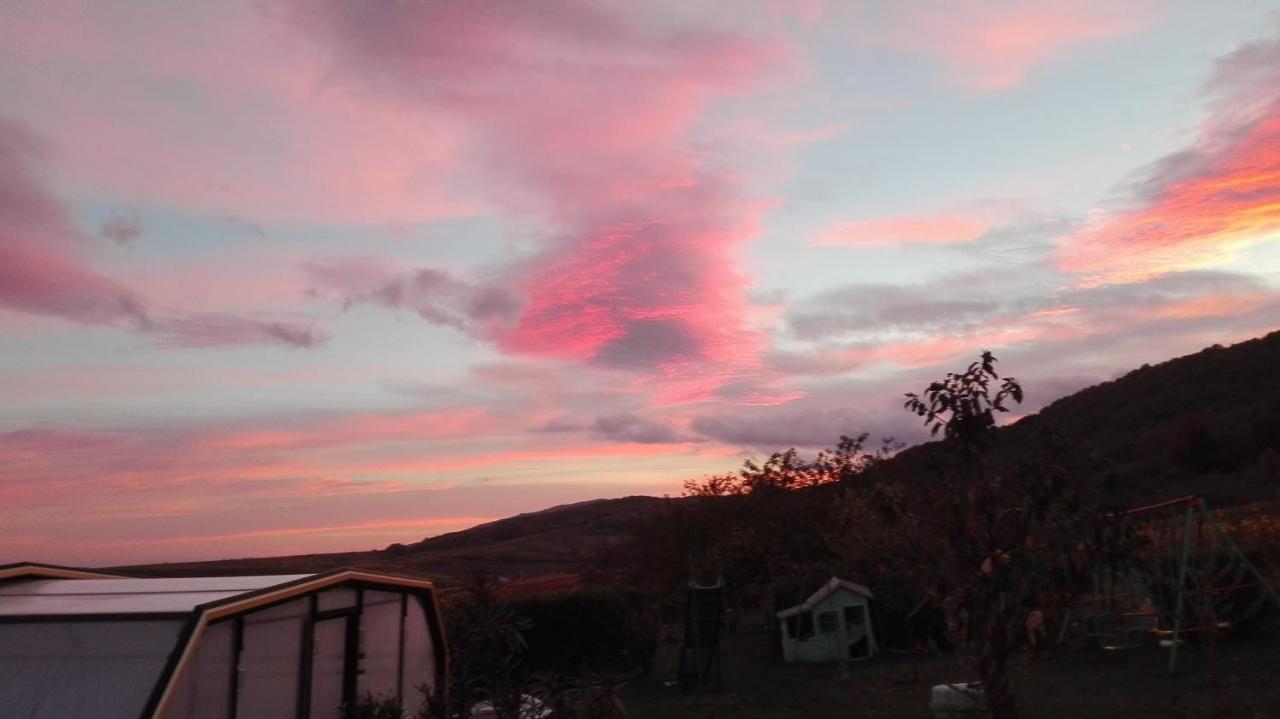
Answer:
(298, 1, 787, 399)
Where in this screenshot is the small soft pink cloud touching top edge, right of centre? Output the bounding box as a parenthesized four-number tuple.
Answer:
(867, 0, 1151, 92)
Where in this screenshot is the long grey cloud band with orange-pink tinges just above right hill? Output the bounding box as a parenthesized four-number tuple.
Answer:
(769, 270, 1280, 377)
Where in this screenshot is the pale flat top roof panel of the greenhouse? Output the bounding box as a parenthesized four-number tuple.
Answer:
(0, 574, 312, 617)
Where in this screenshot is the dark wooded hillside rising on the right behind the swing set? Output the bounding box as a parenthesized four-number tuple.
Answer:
(882, 331, 1280, 507)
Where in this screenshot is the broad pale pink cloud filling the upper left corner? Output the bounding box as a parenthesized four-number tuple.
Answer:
(0, 0, 477, 223)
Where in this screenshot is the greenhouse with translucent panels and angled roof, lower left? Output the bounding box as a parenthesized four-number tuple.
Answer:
(0, 564, 445, 719)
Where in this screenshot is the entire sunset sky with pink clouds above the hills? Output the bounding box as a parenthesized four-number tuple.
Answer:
(0, 0, 1280, 565)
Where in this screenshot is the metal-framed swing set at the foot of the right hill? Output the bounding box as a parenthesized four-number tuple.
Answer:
(1057, 496, 1280, 673)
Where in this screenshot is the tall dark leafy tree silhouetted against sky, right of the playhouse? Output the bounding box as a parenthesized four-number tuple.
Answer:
(901, 352, 1129, 719)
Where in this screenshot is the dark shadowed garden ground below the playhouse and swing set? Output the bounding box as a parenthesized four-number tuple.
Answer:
(620, 614, 1280, 719)
